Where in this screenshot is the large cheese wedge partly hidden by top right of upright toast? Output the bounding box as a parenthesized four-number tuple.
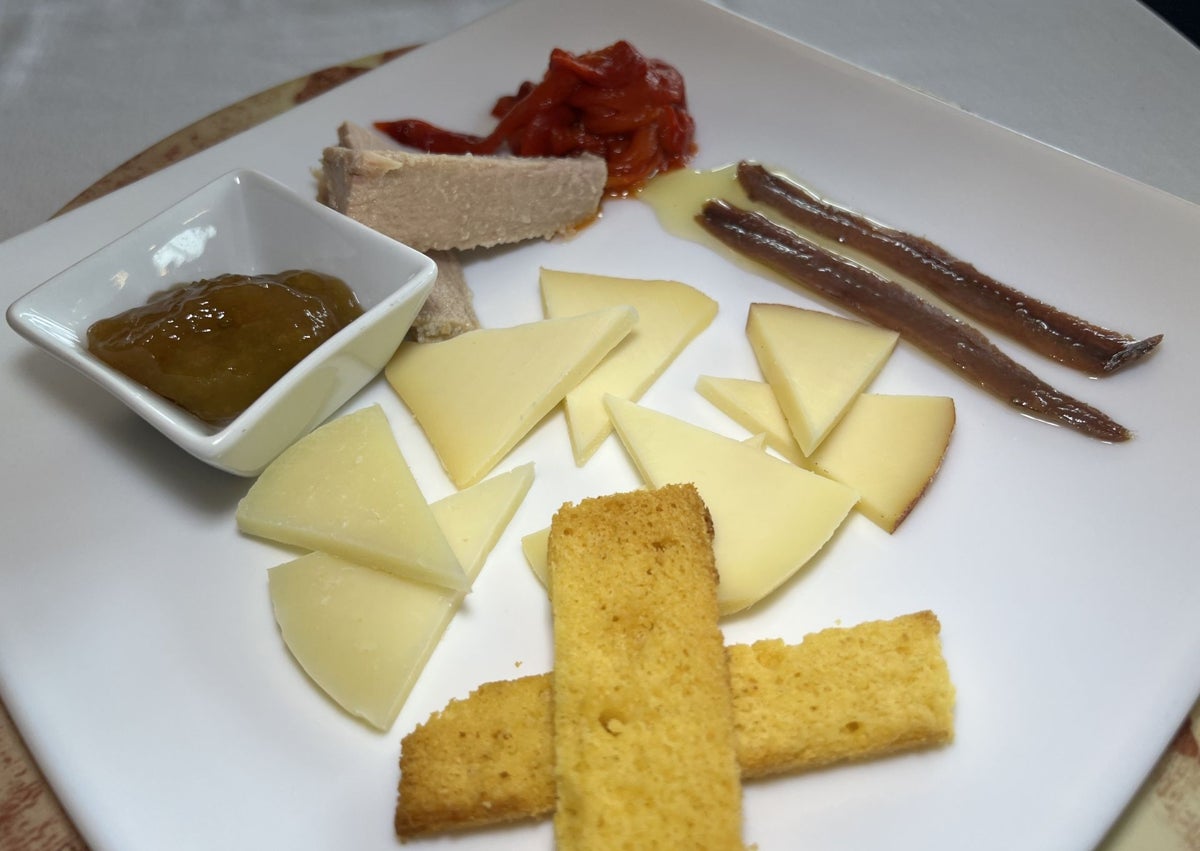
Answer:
(605, 396, 858, 613)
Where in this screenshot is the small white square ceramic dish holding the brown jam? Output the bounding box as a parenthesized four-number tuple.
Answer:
(7, 169, 437, 475)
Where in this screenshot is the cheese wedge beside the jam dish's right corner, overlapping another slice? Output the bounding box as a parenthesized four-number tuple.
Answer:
(385, 306, 637, 487)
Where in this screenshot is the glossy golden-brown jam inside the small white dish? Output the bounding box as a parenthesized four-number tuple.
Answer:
(88, 269, 362, 425)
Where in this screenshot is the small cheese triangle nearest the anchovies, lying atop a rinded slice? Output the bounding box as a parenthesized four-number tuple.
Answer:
(746, 304, 900, 456)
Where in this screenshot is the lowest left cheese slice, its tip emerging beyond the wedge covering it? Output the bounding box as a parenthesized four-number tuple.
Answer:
(268, 465, 533, 730)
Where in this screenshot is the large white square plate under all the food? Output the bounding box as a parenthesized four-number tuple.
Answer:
(0, 0, 1200, 851)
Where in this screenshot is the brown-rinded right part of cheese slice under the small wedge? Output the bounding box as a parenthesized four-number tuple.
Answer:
(809, 394, 954, 532)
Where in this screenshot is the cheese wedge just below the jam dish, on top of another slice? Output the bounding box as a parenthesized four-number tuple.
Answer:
(238, 404, 470, 591)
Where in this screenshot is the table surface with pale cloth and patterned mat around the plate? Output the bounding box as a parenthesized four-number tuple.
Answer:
(0, 0, 1200, 851)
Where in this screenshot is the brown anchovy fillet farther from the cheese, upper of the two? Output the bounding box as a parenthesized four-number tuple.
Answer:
(738, 162, 1163, 376)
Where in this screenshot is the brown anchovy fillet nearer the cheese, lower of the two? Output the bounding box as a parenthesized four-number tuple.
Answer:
(696, 200, 1133, 442)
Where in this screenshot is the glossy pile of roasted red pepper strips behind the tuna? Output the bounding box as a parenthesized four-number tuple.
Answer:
(374, 41, 696, 194)
